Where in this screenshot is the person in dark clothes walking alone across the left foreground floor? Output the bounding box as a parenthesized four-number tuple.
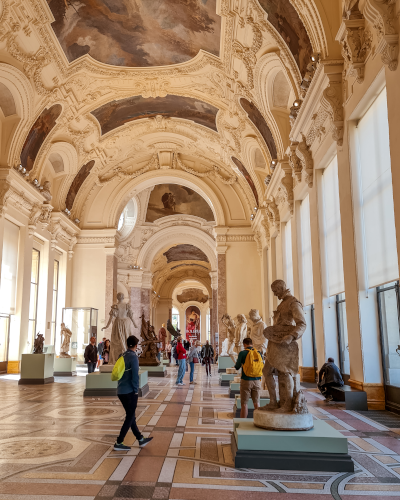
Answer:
(114, 335, 153, 451)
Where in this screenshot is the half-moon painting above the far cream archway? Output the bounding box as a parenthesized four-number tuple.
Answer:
(146, 184, 214, 222)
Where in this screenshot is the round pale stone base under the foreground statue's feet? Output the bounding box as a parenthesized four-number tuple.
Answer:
(253, 410, 314, 431)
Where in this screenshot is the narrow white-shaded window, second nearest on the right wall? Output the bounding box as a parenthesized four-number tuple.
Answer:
(322, 156, 344, 296)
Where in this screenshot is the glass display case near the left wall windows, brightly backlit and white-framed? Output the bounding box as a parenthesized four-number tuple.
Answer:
(61, 307, 99, 363)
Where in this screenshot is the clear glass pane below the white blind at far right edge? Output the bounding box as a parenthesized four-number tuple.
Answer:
(379, 289, 400, 387)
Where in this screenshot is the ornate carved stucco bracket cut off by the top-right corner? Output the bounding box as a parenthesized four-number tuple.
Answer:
(359, 0, 399, 71)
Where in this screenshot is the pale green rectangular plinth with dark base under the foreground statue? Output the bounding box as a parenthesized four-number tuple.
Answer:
(231, 418, 354, 472)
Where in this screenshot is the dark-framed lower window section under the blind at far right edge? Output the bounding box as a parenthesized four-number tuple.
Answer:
(377, 281, 400, 387)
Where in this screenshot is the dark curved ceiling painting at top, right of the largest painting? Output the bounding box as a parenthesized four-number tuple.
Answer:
(258, 0, 313, 76)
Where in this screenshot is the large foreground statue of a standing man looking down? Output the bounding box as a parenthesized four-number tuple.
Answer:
(260, 280, 306, 413)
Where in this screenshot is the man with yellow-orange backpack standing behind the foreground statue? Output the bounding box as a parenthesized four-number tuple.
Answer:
(235, 338, 264, 418)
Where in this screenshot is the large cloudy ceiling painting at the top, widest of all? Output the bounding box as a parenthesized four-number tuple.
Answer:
(47, 0, 221, 67)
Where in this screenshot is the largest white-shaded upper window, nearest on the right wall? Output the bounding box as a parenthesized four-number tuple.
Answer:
(355, 89, 399, 288)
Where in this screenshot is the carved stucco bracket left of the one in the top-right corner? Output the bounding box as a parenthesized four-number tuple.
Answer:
(336, 19, 373, 83)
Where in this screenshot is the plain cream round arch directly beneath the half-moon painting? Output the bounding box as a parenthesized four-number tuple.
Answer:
(137, 226, 217, 271)
